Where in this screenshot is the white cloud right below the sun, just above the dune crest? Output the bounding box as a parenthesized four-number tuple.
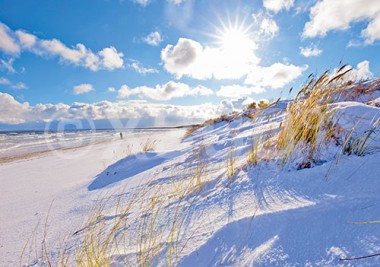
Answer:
(245, 63, 308, 88)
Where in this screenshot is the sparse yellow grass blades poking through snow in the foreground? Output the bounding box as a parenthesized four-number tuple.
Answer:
(20, 152, 208, 267)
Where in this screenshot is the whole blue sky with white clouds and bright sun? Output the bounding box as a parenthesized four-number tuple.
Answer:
(0, 0, 380, 130)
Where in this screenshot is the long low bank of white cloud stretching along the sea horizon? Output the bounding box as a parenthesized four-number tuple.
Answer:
(0, 93, 241, 127)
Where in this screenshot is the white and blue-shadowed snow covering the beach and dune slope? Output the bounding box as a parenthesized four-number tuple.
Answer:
(0, 93, 380, 267)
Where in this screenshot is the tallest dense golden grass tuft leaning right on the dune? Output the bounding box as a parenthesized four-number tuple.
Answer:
(278, 66, 351, 163)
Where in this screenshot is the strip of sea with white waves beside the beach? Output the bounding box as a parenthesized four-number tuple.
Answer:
(0, 129, 151, 159)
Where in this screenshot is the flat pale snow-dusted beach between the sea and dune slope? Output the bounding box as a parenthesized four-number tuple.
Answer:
(0, 129, 185, 266)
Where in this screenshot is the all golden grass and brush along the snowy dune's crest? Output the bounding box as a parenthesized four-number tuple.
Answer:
(185, 65, 380, 170)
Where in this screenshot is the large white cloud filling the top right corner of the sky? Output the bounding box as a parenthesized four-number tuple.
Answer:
(302, 0, 380, 44)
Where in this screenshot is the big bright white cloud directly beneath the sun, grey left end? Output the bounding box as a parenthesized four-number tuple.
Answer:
(161, 38, 260, 80)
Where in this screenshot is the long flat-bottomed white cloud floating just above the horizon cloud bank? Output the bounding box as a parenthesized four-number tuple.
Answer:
(118, 81, 213, 100)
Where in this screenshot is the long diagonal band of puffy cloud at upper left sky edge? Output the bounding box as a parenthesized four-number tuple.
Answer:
(0, 23, 124, 71)
